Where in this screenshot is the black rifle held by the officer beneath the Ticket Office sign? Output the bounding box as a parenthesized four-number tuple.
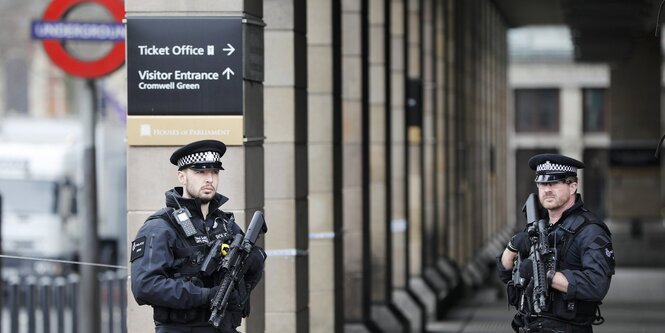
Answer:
(201, 211, 268, 328)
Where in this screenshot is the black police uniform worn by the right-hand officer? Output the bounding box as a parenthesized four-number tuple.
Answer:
(497, 154, 615, 332)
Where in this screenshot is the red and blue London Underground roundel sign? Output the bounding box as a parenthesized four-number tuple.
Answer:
(38, 0, 125, 78)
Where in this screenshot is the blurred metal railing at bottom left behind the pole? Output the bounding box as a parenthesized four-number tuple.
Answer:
(0, 270, 127, 333)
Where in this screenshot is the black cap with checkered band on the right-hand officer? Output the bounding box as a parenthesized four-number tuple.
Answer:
(529, 154, 584, 184)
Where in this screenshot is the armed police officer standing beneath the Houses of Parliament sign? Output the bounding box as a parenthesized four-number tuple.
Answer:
(130, 140, 265, 333)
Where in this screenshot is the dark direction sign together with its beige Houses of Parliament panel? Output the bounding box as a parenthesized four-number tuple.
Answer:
(127, 16, 262, 146)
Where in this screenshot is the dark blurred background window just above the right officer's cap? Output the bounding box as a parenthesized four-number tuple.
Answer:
(515, 88, 559, 132)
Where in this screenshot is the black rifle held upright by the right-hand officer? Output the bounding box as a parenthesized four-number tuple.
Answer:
(512, 193, 557, 314)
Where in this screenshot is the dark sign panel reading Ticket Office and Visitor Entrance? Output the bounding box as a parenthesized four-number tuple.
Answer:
(127, 16, 243, 116)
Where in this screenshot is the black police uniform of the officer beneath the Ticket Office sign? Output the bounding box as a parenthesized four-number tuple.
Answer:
(130, 142, 265, 333)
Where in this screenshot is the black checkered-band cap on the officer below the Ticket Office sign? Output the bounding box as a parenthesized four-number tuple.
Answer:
(170, 140, 226, 170)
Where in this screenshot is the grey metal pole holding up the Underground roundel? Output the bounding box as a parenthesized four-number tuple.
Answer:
(78, 79, 101, 332)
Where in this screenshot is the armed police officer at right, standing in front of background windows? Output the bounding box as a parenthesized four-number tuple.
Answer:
(497, 154, 614, 332)
